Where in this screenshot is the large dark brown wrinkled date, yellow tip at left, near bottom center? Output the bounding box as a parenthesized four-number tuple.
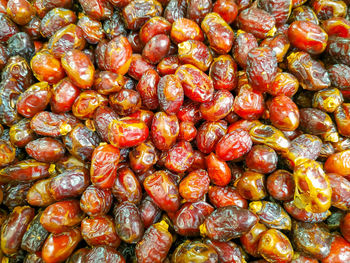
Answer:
(200, 206, 258, 241)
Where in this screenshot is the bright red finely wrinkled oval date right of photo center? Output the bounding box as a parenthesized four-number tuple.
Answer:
(215, 129, 253, 161)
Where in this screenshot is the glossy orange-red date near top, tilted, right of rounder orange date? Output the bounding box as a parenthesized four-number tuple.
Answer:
(201, 13, 234, 54)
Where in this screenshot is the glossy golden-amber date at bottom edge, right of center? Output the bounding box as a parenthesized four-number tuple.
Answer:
(258, 229, 294, 263)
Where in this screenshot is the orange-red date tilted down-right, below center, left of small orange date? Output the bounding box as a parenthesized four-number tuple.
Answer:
(143, 171, 180, 212)
